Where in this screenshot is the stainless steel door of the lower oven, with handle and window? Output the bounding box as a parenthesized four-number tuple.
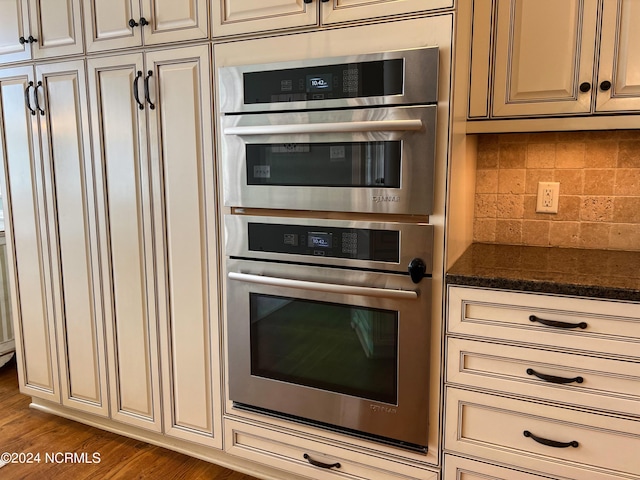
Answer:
(227, 259, 431, 450)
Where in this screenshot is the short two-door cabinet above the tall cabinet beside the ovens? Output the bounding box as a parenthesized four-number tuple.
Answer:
(83, 0, 209, 52)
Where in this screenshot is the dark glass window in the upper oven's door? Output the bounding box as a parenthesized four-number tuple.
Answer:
(246, 141, 401, 188)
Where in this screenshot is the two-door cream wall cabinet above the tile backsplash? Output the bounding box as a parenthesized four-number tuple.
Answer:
(469, 0, 640, 118)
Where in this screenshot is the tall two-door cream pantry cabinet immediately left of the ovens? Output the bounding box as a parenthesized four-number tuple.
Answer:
(88, 46, 221, 446)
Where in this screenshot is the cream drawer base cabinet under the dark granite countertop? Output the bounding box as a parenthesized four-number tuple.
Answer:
(444, 286, 640, 480)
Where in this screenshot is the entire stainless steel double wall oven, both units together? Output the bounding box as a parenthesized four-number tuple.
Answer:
(218, 47, 438, 451)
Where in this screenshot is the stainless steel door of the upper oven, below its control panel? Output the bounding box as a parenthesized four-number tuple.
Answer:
(221, 105, 436, 215)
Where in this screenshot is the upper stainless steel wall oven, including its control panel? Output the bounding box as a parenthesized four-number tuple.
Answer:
(218, 47, 438, 215)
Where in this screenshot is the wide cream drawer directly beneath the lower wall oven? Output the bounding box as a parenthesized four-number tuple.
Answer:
(224, 419, 438, 480)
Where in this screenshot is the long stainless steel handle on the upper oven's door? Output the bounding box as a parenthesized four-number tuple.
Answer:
(224, 119, 422, 136)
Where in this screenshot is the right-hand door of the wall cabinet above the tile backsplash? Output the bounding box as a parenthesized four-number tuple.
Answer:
(596, 0, 640, 112)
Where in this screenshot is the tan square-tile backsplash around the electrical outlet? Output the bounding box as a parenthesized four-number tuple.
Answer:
(473, 130, 640, 251)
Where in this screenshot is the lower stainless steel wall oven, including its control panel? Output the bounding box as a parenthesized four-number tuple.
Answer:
(225, 215, 433, 451)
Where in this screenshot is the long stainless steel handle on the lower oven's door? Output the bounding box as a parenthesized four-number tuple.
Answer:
(228, 272, 418, 300)
